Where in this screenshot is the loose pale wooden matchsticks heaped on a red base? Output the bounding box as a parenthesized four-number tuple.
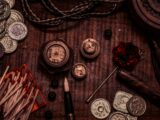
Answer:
(0, 65, 40, 120)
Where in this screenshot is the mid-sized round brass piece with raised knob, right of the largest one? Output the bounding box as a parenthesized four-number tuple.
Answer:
(80, 38, 100, 59)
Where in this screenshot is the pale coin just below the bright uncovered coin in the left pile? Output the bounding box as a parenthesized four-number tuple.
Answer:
(0, 36, 18, 53)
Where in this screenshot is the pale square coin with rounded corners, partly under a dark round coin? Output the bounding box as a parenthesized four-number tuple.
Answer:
(113, 91, 132, 113)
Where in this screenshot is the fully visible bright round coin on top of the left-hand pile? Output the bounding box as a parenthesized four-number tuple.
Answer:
(8, 22, 28, 41)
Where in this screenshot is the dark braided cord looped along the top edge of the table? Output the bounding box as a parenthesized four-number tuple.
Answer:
(21, 0, 122, 27)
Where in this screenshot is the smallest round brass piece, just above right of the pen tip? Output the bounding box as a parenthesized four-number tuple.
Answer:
(72, 63, 88, 79)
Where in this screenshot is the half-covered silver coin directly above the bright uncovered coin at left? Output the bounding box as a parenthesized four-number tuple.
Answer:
(7, 9, 24, 27)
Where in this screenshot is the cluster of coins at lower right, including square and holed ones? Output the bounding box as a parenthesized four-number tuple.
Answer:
(91, 91, 146, 120)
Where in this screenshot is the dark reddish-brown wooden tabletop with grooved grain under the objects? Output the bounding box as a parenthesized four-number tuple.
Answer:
(0, 0, 160, 120)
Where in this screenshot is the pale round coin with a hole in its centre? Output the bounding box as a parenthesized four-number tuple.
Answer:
(91, 98, 111, 119)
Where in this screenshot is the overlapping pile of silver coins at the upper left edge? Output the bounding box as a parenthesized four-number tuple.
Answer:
(0, 0, 28, 58)
